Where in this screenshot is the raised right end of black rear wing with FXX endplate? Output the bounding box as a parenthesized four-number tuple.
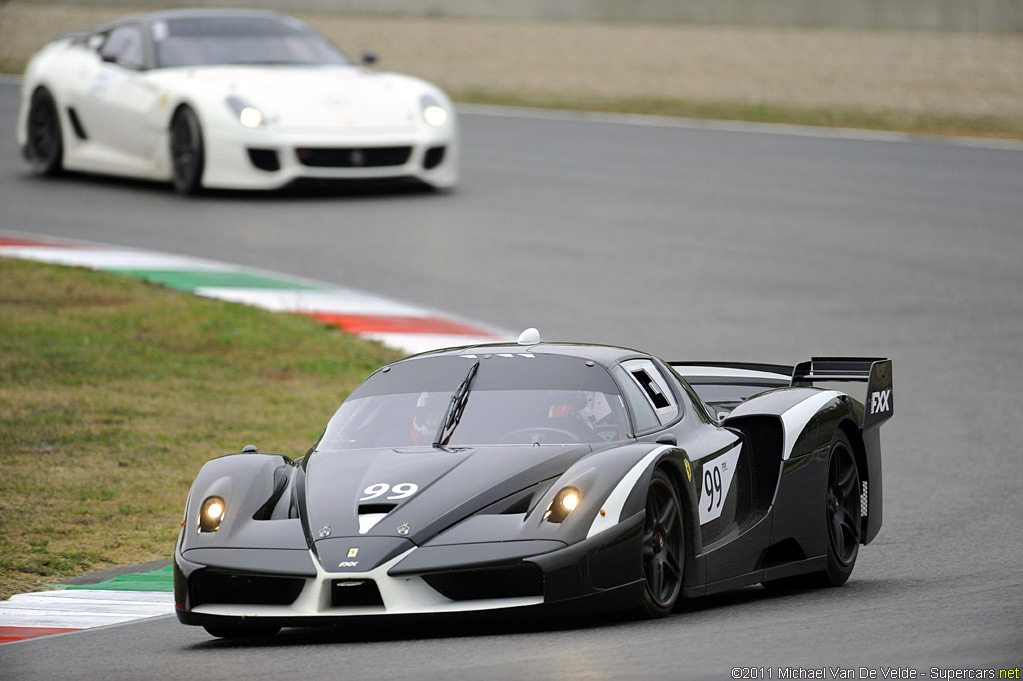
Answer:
(792, 357, 895, 430)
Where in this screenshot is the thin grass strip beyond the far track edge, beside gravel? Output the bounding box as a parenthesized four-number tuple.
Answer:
(452, 90, 1023, 139)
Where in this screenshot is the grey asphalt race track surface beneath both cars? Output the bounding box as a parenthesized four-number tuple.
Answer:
(0, 80, 1023, 681)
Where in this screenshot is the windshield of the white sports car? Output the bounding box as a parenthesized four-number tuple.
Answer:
(152, 16, 351, 66)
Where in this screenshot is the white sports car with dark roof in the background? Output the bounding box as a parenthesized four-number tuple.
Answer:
(17, 9, 458, 193)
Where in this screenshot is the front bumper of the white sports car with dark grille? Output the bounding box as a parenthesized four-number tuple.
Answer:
(203, 125, 458, 189)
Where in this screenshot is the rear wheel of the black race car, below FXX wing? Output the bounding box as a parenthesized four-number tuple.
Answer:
(763, 430, 860, 591)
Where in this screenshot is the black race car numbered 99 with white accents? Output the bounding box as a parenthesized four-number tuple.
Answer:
(174, 329, 894, 636)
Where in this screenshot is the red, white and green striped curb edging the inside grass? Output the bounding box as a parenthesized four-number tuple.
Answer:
(0, 233, 514, 643)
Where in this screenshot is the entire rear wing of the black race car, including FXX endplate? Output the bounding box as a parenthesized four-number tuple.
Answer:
(668, 357, 895, 430)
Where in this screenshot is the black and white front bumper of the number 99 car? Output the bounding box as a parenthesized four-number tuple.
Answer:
(174, 513, 642, 627)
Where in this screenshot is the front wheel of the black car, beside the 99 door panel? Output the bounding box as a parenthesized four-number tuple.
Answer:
(639, 470, 685, 619)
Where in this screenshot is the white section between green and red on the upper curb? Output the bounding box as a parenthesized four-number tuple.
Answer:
(193, 286, 430, 317)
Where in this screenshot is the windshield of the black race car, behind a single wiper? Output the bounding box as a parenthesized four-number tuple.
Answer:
(318, 354, 629, 450)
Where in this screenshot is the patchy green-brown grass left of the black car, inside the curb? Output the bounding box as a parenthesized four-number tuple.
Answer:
(0, 258, 397, 598)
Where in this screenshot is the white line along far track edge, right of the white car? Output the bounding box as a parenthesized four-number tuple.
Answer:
(457, 104, 1023, 151)
